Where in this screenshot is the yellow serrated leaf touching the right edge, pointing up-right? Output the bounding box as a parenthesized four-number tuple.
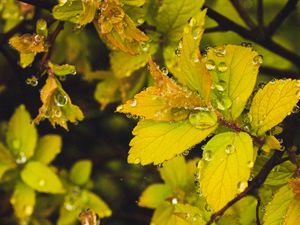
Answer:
(249, 79, 300, 135)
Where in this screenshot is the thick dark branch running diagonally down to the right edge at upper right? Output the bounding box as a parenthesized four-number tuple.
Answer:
(204, 6, 300, 67)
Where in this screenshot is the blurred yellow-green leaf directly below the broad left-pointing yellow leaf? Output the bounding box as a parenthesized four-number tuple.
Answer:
(159, 157, 188, 188)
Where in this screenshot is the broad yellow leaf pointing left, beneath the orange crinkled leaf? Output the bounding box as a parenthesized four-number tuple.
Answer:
(128, 120, 216, 165)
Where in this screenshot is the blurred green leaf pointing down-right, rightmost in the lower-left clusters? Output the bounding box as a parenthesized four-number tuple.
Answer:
(84, 191, 112, 218)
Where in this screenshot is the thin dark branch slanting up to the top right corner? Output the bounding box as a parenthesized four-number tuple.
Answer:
(267, 0, 299, 37)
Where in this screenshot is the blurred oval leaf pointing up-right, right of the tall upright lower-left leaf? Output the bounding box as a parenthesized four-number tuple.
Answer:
(33, 134, 62, 164)
